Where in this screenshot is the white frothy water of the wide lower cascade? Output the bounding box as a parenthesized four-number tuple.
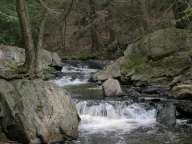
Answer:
(76, 101, 156, 133)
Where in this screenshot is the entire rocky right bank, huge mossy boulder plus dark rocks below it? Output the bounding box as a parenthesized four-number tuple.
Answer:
(93, 28, 192, 125)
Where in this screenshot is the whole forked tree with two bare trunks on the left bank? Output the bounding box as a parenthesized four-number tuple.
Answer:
(16, 0, 74, 77)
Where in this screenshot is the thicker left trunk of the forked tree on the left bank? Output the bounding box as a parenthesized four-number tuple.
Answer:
(16, 0, 36, 73)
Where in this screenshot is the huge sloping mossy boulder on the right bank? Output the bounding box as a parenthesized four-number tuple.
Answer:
(96, 28, 192, 84)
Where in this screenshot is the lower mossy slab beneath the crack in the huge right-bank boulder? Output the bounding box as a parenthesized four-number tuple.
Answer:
(120, 52, 191, 82)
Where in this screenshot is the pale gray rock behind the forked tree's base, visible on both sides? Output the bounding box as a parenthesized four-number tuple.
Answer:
(0, 45, 61, 70)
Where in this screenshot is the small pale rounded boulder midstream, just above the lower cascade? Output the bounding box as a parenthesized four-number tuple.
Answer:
(103, 78, 123, 97)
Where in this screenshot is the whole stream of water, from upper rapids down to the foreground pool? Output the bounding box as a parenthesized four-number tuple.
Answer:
(54, 65, 192, 144)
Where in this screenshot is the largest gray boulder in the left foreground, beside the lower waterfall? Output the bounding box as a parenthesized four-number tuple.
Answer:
(0, 79, 79, 143)
